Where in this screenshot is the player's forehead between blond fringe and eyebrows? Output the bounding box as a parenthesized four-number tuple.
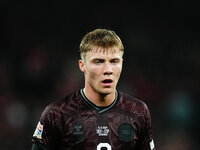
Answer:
(86, 47, 123, 60)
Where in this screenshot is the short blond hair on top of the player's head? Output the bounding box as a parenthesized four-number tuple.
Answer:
(80, 29, 124, 60)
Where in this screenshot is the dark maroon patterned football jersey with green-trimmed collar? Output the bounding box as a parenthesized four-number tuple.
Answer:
(32, 90, 155, 150)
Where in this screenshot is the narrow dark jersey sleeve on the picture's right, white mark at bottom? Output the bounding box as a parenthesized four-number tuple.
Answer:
(136, 104, 156, 150)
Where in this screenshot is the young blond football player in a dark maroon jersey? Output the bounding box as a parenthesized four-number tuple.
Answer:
(32, 29, 155, 150)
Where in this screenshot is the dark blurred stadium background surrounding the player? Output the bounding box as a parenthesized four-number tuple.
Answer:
(0, 0, 200, 150)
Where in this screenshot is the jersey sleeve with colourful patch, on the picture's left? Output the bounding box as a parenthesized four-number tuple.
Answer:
(32, 103, 61, 149)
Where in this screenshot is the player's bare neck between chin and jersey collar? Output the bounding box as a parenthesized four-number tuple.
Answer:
(83, 88, 115, 106)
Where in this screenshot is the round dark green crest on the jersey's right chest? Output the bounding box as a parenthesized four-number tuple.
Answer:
(118, 123, 134, 142)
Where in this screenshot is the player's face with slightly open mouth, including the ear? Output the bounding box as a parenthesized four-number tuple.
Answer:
(79, 48, 123, 95)
